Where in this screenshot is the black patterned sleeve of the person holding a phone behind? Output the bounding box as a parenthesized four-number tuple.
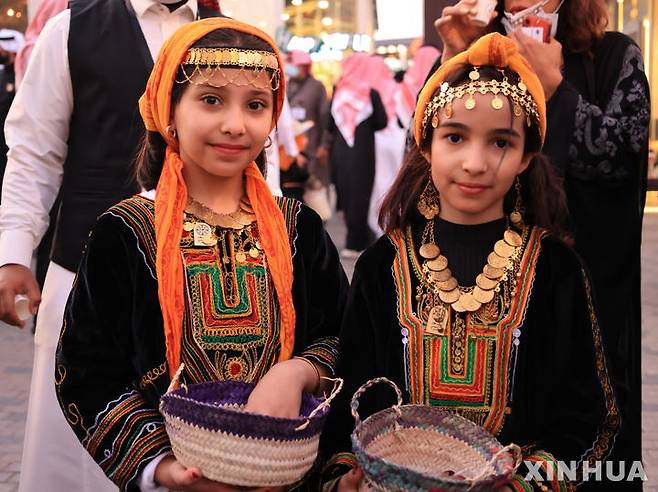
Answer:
(548, 44, 650, 186)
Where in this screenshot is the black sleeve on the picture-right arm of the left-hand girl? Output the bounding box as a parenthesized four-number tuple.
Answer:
(296, 207, 348, 375)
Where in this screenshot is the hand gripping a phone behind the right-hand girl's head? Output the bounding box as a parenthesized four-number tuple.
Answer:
(509, 29, 564, 100)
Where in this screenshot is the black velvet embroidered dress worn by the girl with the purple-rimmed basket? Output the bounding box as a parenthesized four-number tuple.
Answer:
(55, 196, 347, 491)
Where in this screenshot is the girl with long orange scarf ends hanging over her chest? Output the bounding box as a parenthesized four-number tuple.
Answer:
(57, 19, 347, 490)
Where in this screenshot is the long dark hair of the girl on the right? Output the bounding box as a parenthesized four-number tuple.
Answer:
(379, 65, 570, 242)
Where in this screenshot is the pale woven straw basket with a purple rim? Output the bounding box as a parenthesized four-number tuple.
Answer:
(160, 366, 342, 487)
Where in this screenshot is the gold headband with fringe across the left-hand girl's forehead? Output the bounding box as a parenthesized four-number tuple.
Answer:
(176, 48, 281, 91)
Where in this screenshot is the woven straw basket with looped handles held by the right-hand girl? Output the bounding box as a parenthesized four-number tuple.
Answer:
(352, 378, 521, 492)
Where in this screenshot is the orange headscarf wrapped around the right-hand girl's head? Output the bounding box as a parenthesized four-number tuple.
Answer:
(414, 33, 546, 145)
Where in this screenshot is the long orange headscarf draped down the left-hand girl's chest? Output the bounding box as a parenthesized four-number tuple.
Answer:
(139, 17, 295, 376)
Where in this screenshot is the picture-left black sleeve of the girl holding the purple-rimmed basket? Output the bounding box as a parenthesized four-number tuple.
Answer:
(55, 214, 170, 491)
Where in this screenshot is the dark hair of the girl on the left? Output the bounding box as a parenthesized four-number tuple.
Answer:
(135, 29, 278, 190)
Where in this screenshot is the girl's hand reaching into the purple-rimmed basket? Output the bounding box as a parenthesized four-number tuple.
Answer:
(245, 359, 318, 418)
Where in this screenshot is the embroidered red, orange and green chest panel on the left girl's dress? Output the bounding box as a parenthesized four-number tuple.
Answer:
(181, 214, 280, 382)
